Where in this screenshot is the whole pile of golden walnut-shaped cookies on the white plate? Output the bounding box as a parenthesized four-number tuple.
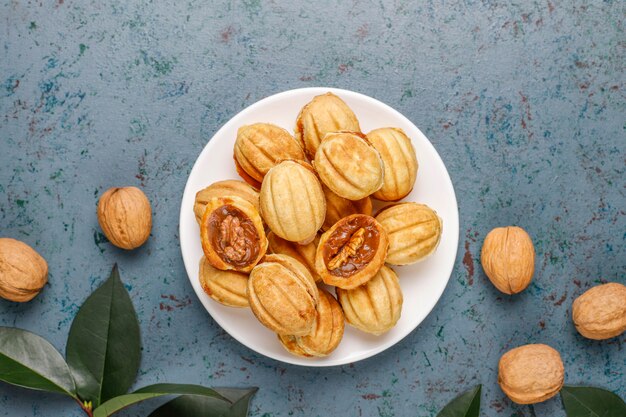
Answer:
(194, 93, 442, 357)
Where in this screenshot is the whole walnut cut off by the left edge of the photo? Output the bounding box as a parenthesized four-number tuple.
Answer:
(0, 237, 48, 303)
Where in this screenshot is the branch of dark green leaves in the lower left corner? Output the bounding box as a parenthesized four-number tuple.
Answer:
(0, 265, 257, 417)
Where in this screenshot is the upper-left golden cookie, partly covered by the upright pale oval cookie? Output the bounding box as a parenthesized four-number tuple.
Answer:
(233, 123, 305, 189)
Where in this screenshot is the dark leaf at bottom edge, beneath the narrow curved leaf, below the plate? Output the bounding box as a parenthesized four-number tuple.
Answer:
(148, 388, 258, 417)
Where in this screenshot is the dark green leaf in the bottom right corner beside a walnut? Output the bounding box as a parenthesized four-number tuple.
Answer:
(561, 385, 626, 417)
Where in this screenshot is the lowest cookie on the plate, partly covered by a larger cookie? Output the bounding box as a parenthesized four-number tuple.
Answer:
(278, 288, 344, 357)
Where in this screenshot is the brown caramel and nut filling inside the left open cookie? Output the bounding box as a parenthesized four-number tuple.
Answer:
(208, 205, 260, 267)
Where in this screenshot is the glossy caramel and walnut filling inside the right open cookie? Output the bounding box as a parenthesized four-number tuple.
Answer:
(323, 216, 380, 277)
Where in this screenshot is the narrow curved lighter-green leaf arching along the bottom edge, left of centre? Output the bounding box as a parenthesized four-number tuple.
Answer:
(93, 384, 231, 417)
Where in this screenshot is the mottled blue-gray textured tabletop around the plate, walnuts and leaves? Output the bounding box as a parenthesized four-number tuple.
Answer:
(0, 0, 626, 417)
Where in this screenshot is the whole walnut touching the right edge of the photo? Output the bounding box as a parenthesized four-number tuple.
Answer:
(572, 282, 626, 340)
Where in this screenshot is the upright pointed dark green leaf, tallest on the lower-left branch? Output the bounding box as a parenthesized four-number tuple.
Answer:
(66, 264, 141, 408)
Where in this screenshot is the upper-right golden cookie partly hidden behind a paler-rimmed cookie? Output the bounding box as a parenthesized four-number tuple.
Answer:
(367, 127, 417, 201)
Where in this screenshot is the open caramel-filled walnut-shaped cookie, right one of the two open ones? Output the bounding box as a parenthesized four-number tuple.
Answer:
(315, 214, 389, 289)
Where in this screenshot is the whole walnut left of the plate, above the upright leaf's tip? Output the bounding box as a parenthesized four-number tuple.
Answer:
(98, 187, 152, 250)
